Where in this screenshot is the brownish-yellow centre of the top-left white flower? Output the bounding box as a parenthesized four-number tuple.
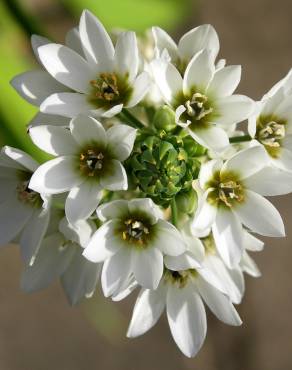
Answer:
(90, 73, 120, 102)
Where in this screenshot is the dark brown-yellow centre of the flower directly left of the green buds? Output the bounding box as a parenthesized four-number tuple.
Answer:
(79, 149, 104, 177)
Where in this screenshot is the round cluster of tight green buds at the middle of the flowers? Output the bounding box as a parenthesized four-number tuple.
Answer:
(125, 131, 201, 210)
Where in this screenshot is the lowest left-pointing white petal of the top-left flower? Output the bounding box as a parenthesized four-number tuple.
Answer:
(40, 93, 98, 118)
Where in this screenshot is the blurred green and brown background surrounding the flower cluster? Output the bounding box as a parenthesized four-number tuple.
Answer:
(0, 0, 292, 370)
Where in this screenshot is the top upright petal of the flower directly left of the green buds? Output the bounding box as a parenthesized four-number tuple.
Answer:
(70, 115, 107, 147)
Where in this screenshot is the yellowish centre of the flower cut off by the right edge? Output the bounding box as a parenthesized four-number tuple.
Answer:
(257, 121, 286, 148)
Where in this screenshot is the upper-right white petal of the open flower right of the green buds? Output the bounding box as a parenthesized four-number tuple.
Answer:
(221, 145, 269, 181)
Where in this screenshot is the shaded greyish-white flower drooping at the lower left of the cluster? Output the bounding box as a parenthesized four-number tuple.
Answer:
(21, 218, 101, 305)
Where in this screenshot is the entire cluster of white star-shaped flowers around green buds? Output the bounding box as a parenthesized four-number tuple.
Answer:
(4, 7, 292, 357)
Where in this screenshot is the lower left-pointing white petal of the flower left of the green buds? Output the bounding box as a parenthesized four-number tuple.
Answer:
(29, 156, 83, 194)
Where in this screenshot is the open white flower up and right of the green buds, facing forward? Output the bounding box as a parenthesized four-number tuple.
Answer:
(152, 50, 254, 151)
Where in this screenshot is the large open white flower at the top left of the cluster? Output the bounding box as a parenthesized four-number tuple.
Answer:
(13, 11, 149, 118)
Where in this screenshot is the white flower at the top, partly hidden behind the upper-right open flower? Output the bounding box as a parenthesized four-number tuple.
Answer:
(152, 24, 220, 72)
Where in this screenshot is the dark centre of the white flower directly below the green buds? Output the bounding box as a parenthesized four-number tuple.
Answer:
(122, 218, 150, 246)
